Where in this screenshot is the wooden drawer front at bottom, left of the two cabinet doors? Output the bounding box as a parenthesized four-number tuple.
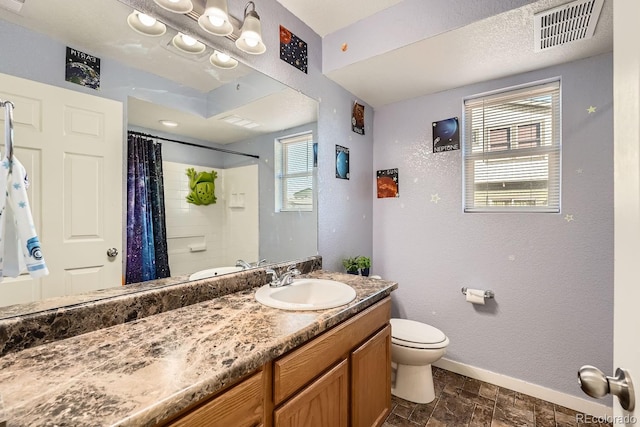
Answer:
(169, 371, 264, 427)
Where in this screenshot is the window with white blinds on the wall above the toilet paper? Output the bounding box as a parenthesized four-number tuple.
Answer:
(462, 78, 562, 213)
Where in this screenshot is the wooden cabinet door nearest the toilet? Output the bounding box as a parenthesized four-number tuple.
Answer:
(351, 325, 391, 427)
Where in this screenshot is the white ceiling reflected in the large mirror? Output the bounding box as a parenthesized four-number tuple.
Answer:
(0, 0, 317, 144)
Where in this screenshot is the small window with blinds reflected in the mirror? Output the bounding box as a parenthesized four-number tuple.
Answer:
(275, 132, 313, 212)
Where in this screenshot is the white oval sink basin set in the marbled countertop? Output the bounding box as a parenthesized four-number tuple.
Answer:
(256, 279, 356, 310)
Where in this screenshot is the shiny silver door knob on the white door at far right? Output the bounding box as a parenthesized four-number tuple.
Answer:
(578, 365, 636, 411)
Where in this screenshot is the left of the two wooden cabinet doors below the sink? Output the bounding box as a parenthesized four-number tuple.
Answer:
(274, 359, 349, 427)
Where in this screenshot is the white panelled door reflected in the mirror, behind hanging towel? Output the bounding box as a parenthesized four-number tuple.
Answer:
(0, 74, 123, 305)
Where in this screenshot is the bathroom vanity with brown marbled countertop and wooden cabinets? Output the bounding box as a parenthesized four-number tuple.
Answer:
(0, 270, 397, 427)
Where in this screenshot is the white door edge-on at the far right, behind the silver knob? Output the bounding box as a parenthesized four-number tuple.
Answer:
(612, 0, 640, 426)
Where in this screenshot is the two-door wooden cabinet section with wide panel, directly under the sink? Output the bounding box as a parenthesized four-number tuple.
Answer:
(273, 298, 391, 427)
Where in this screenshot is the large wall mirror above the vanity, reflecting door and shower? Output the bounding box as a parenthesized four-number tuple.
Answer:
(0, 0, 318, 316)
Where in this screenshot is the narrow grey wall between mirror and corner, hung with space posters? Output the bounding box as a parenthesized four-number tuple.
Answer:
(229, 0, 374, 271)
